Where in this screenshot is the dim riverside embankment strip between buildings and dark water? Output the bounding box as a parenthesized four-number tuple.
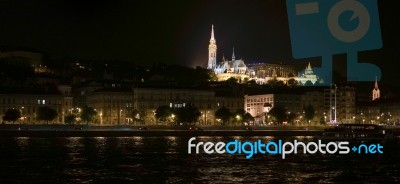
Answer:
(0, 124, 400, 137)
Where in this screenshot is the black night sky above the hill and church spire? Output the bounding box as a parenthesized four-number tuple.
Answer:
(0, 0, 400, 84)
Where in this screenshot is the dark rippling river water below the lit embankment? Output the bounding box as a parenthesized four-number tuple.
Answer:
(0, 137, 400, 184)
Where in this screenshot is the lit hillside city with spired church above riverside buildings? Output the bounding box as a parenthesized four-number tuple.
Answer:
(0, 25, 400, 136)
